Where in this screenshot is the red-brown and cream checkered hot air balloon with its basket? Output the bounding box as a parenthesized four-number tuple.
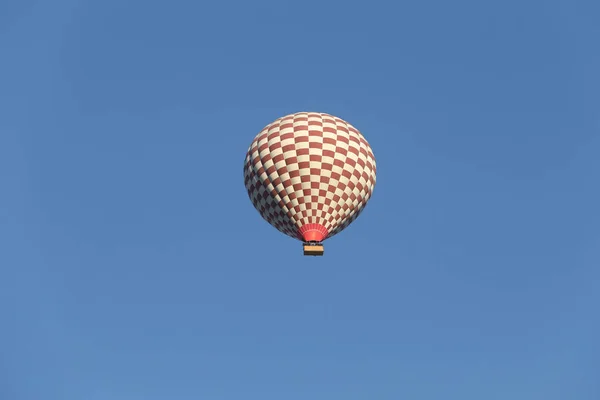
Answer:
(244, 112, 376, 256)
